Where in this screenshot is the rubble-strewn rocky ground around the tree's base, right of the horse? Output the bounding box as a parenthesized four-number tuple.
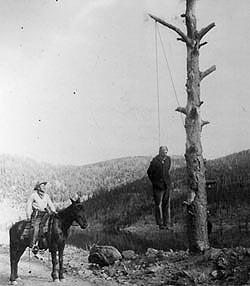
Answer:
(55, 244, 250, 286)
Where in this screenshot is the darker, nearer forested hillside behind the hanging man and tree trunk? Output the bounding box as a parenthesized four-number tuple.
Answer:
(86, 150, 250, 227)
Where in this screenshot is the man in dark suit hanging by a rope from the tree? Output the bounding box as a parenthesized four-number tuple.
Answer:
(147, 146, 171, 229)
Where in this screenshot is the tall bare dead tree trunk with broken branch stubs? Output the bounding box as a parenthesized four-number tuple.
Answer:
(150, 0, 216, 252)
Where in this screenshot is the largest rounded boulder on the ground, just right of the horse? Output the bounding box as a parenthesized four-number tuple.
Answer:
(88, 245, 122, 267)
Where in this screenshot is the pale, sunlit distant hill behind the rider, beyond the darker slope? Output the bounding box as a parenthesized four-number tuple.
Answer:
(0, 152, 184, 208)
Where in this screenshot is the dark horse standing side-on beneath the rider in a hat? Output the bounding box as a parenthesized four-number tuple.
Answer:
(9, 199, 88, 285)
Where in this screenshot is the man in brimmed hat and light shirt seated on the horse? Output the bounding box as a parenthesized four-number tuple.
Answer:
(26, 182, 56, 255)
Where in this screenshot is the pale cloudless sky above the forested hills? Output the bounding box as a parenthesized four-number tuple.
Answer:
(0, 0, 250, 165)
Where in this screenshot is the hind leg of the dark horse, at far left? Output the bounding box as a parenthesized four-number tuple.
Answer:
(10, 244, 27, 284)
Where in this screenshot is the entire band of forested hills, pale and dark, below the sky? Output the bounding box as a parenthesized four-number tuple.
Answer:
(0, 150, 250, 226)
